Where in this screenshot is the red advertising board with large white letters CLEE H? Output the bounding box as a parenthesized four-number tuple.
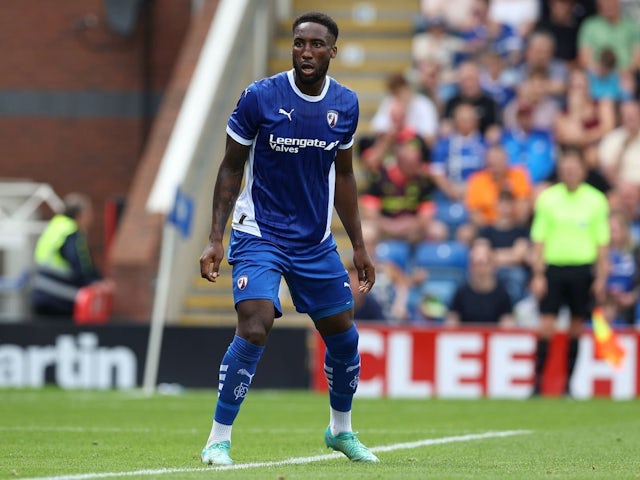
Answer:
(313, 325, 640, 399)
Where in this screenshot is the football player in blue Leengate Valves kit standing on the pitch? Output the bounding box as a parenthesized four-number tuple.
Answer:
(200, 12, 378, 465)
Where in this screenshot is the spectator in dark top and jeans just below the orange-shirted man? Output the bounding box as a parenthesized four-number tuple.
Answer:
(476, 190, 531, 305)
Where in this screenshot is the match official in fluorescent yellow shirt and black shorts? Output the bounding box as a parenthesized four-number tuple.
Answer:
(530, 148, 609, 395)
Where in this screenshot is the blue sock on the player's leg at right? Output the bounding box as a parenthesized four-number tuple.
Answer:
(323, 325, 360, 412)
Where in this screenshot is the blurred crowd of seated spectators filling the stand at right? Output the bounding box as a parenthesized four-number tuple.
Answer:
(356, 0, 640, 328)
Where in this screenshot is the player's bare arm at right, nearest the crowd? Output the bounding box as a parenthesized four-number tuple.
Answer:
(335, 147, 376, 293)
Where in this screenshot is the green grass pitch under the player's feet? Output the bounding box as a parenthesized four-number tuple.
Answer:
(0, 388, 640, 480)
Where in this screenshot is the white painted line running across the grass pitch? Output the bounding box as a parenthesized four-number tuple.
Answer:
(22, 430, 531, 480)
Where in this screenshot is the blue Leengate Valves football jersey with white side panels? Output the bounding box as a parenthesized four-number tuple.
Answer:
(227, 70, 359, 247)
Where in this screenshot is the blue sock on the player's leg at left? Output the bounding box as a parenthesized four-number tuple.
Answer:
(213, 335, 264, 425)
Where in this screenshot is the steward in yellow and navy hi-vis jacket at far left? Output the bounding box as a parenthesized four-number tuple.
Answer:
(31, 193, 113, 322)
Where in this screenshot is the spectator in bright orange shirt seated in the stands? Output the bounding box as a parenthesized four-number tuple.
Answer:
(465, 145, 533, 227)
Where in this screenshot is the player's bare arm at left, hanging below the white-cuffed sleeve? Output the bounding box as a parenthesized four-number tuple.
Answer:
(200, 135, 251, 282)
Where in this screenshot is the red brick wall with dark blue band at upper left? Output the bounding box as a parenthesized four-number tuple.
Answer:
(0, 0, 201, 318)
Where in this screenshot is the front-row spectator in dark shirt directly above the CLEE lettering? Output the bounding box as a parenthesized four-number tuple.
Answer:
(445, 243, 514, 328)
